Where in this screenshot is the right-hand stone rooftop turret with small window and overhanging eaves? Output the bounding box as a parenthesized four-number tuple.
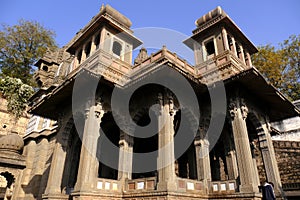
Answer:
(185, 7, 257, 83)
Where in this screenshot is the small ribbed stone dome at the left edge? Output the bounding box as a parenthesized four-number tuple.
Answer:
(0, 133, 24, 153)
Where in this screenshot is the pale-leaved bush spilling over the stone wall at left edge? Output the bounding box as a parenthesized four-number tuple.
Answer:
(0, 77, 34, 119)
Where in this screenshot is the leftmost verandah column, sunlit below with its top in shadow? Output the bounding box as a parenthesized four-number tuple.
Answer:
(45, 115, 73, 199)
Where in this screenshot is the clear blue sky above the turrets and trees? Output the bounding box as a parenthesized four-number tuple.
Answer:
(0, 0, 300, 46)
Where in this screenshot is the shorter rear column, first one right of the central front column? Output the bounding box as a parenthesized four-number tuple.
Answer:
(194, 138, 211, 193)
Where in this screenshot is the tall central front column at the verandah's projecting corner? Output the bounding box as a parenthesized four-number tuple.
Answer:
(157, 91, 177, 190)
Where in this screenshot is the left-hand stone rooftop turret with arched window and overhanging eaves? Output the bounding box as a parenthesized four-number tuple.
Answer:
(67, 5, 141, 72)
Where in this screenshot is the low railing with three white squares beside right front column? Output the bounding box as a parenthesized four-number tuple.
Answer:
(210, 180, 238, 193)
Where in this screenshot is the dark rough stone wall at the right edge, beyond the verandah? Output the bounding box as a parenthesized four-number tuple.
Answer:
(273, 141, 300, 184)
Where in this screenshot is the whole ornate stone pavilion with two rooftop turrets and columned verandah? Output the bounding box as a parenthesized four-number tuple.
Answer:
(1, 5, 298, 200)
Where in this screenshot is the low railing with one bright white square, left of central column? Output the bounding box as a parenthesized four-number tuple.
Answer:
(126, 177, 156, 191)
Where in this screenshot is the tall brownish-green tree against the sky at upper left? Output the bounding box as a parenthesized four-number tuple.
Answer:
(0, 19, 57, 85)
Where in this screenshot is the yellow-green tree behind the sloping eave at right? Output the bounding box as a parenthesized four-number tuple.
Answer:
(252, 35, 300, 100)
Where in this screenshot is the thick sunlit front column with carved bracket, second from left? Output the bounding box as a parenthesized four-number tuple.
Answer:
(75, 101, 104, 192)
